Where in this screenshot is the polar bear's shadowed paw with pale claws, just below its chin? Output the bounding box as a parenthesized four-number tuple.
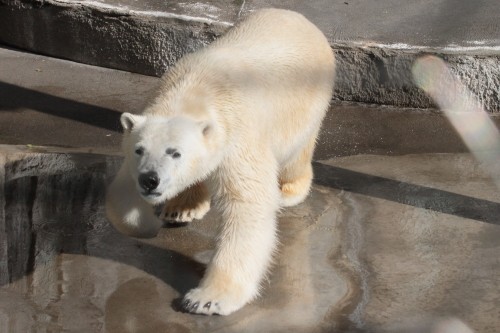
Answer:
(160, 182, 210, 222)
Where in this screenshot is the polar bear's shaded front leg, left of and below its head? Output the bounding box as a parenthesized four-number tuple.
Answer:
(106, 160, 163, 238)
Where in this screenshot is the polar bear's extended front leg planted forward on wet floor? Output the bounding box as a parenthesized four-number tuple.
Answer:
(182, 158, 280, 315)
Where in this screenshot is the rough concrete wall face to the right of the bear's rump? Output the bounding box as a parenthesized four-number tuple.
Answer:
(334, 45, 500, 112)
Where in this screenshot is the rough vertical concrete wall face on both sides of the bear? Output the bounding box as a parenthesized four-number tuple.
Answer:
(0, 0, 500, 113)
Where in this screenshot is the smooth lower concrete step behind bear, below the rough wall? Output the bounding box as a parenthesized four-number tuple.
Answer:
(0, 48, 500, 159)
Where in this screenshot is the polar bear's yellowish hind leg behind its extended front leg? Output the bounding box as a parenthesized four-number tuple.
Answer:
(279, 135, 316, 207)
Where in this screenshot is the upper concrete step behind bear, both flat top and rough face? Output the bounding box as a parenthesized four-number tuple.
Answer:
(0, 0, 500, 113)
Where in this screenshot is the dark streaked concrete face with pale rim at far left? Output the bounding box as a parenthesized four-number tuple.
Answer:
(2, 155, 113, 284)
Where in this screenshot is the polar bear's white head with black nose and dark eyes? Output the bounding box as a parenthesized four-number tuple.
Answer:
(120, 113, 219, 204)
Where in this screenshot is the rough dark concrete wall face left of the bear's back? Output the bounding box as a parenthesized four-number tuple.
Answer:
(0, 0, 224, 76)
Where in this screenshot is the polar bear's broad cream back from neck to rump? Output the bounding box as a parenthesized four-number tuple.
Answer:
(147, 9, 335, 162)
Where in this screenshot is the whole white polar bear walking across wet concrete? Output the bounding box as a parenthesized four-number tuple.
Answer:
(106, 9, 335, 315)
